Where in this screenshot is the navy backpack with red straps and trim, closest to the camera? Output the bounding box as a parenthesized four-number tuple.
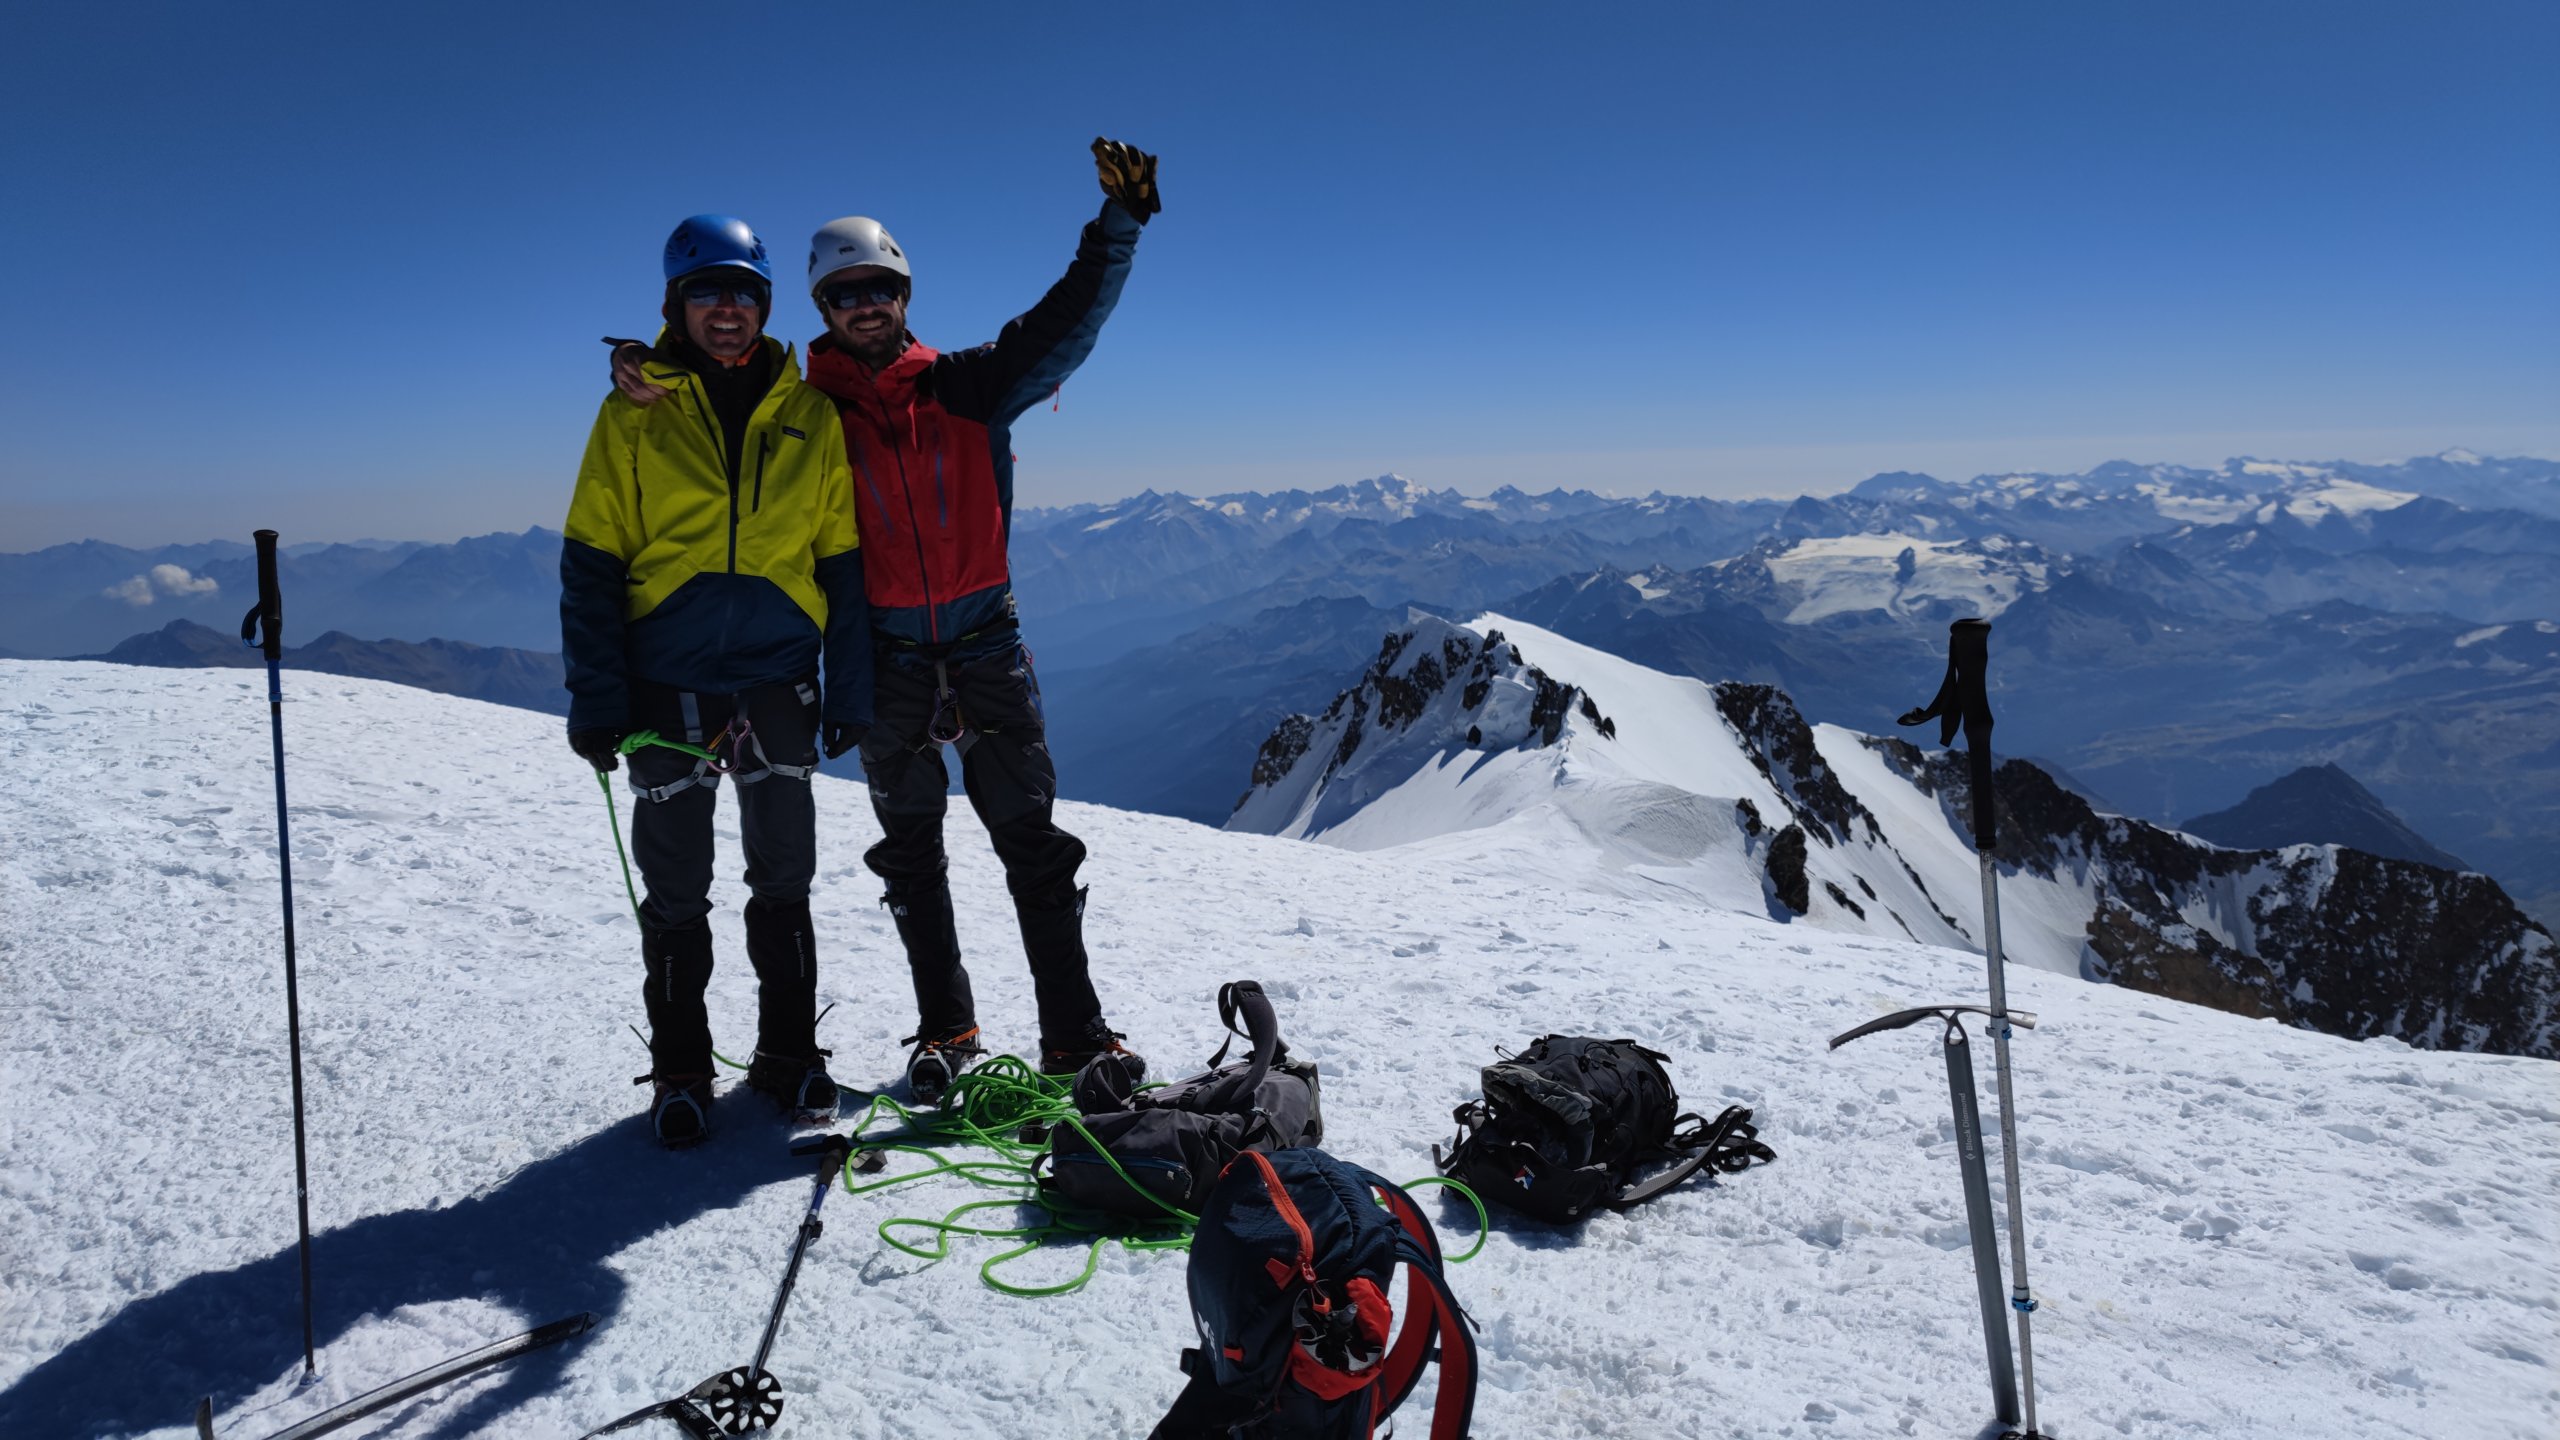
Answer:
(1149, 1150, 1475, 1440)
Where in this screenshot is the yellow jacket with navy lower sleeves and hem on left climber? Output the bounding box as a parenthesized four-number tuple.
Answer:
(561, 336, 870, 730)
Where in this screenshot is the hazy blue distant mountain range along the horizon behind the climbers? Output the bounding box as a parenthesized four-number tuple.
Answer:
(20, 451, 2560, 917)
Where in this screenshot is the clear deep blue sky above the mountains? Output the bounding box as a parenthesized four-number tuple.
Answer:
(0, 0, 2560, 551)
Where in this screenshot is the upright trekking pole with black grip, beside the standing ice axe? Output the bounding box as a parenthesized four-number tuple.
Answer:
(1900, 620, 2040, 1440)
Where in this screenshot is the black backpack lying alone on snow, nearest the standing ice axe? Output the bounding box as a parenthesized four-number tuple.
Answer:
(1431, 1035, 1777, 1222)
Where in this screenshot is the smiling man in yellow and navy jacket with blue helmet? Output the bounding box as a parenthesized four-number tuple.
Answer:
(561, 215, 873, 1145)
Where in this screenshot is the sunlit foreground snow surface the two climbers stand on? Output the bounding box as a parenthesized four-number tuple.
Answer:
(0, 661, 2560, 1440)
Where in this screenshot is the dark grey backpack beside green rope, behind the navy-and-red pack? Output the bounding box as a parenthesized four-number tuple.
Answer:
(1034, 979, 1324, 1220)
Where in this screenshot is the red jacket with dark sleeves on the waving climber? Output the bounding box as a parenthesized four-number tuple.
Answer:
(809, 200, 1139, 651)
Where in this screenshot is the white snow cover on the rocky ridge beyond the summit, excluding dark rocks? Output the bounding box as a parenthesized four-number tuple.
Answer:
(1229, 615, 2129, 976)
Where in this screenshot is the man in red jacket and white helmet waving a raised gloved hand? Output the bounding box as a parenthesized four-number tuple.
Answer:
(614, 141, 1160, 1102)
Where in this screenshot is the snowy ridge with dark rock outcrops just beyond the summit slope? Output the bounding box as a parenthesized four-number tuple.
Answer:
(1226, 612, 2560, 1058)
